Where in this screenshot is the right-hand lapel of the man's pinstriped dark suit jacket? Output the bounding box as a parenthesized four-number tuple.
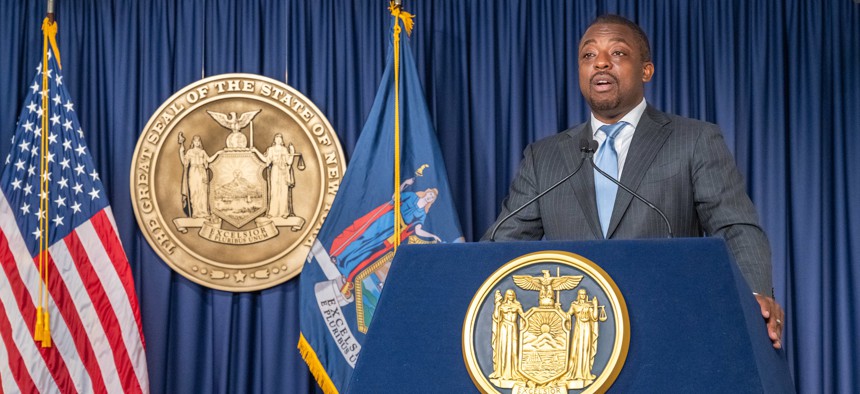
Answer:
(604, 105, 672, 238)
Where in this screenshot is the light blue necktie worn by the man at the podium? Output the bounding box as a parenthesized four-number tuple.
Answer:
(594, 122, 627, 237)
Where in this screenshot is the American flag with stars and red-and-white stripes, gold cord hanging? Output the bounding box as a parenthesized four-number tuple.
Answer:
(0, 45, 149, 393)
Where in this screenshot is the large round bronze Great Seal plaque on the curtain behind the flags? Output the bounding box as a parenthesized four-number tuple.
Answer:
(130, 74, 346, 291)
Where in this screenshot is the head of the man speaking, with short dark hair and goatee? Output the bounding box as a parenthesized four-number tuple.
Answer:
(579, 23, 654, 123)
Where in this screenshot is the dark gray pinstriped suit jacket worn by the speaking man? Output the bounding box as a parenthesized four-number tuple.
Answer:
(484, 105, 772, 295)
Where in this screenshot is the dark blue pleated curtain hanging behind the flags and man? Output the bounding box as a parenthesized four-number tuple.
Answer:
(0, 0, 860, 393)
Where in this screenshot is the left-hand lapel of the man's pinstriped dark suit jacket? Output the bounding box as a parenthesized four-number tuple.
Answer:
(561, 122, 603, 239)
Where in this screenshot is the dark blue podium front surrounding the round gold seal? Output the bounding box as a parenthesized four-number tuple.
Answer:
(349, 238, 794, 393)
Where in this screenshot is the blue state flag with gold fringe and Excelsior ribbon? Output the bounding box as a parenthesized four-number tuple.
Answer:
(298, 4, 463, 393)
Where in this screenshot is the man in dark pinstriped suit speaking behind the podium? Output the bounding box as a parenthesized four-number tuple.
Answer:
(484, 15, 784, 348)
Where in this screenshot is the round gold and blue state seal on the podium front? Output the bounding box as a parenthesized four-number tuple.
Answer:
(463, 251, 630, 394)
